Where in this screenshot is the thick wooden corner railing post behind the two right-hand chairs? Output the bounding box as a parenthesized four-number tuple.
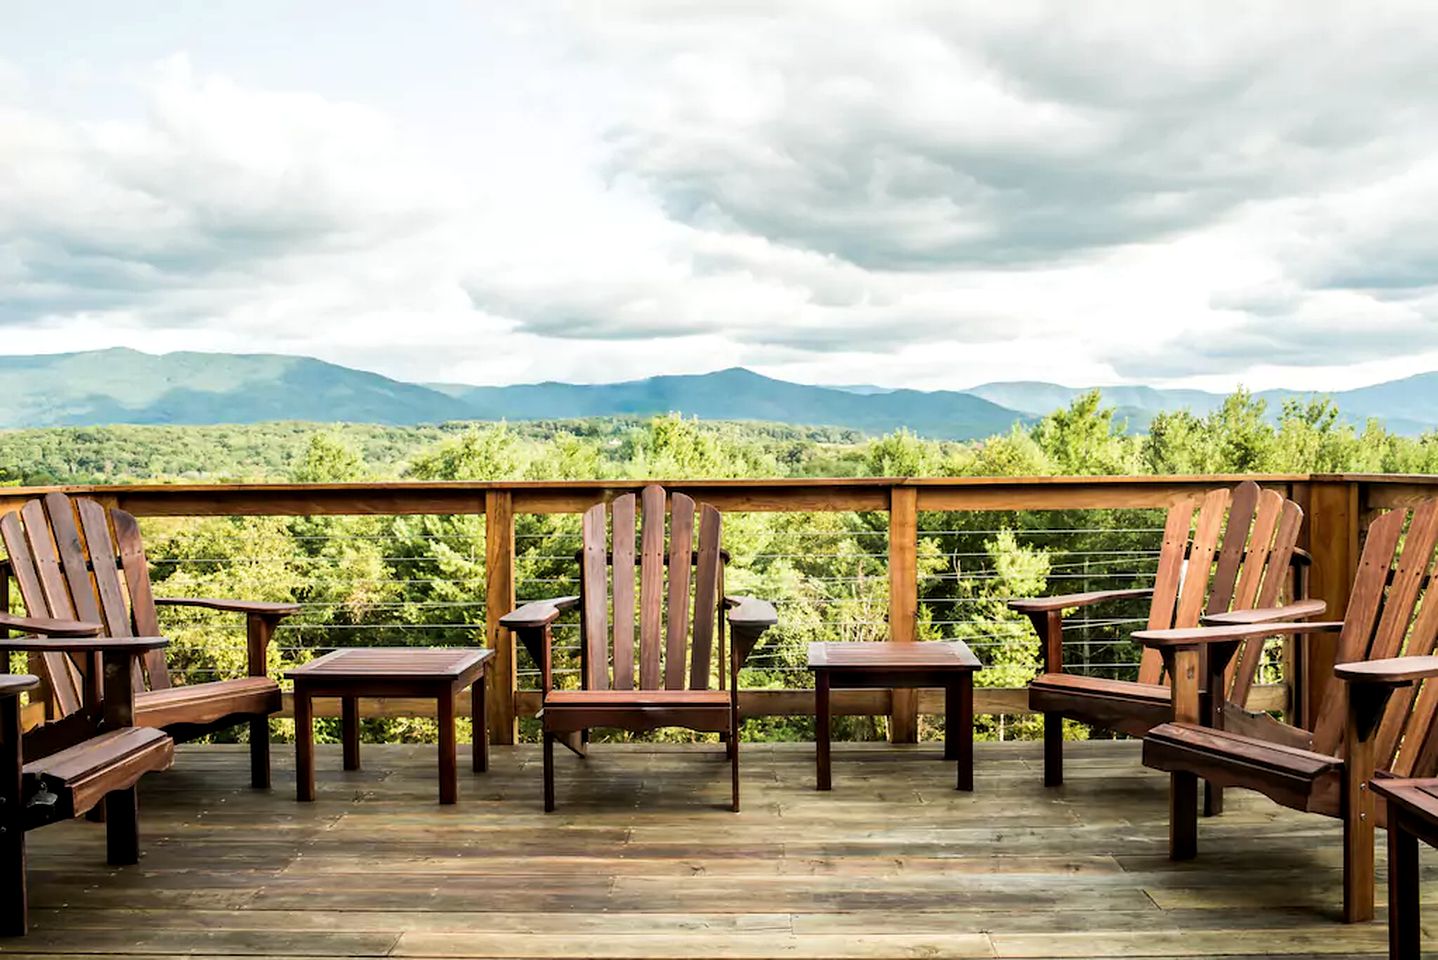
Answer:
(1294, 479, 1362, 729)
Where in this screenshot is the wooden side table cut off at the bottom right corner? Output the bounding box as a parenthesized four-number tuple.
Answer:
(1369, 777, 1438, 959)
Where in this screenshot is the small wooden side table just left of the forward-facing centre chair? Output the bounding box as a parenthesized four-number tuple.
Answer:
(285, 647, 495, 803)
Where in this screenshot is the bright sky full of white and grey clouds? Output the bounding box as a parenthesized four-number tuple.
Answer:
(0, 0, 1438, 389)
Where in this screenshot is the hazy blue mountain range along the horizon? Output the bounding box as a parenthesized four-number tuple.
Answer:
(0, 348, 1438, 440)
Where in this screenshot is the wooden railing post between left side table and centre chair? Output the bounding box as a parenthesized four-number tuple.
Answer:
(485, 490, 519, 744)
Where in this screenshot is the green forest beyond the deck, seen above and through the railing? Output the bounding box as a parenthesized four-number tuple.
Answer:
(0, 391, 1438, 739)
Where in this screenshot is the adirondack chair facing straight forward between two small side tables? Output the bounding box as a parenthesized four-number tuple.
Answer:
(500, 486, 778, 812)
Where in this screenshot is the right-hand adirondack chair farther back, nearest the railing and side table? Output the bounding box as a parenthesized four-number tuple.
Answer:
(1009, 480, 1324, 813)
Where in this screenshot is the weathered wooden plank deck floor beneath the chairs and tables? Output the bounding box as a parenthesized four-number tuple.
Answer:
(0, 743, 1438, 957)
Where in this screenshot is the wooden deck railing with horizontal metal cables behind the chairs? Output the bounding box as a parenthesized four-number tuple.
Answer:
(0, 476, 1414, 743)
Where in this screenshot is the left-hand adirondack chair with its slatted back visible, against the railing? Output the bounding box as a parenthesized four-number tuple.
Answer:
(0, 493, 299, 788)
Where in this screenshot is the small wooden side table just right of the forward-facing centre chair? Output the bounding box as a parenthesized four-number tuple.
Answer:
(808, 640, 982, 790)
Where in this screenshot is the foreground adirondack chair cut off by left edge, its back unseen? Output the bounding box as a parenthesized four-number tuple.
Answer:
(0, 626, 174, 936)
